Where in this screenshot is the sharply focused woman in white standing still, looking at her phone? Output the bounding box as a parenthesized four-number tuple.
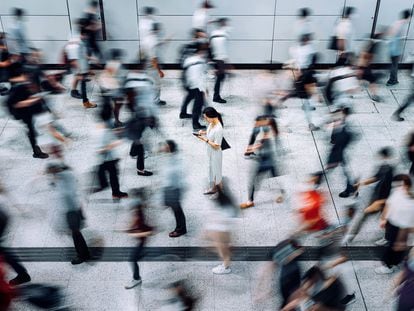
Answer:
(197, 107, 223, 195)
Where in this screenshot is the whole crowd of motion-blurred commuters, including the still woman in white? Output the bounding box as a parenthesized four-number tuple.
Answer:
(0, 1, 414, 311)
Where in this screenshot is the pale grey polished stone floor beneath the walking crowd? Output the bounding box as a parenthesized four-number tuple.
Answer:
(0, 70, 414, 311)
